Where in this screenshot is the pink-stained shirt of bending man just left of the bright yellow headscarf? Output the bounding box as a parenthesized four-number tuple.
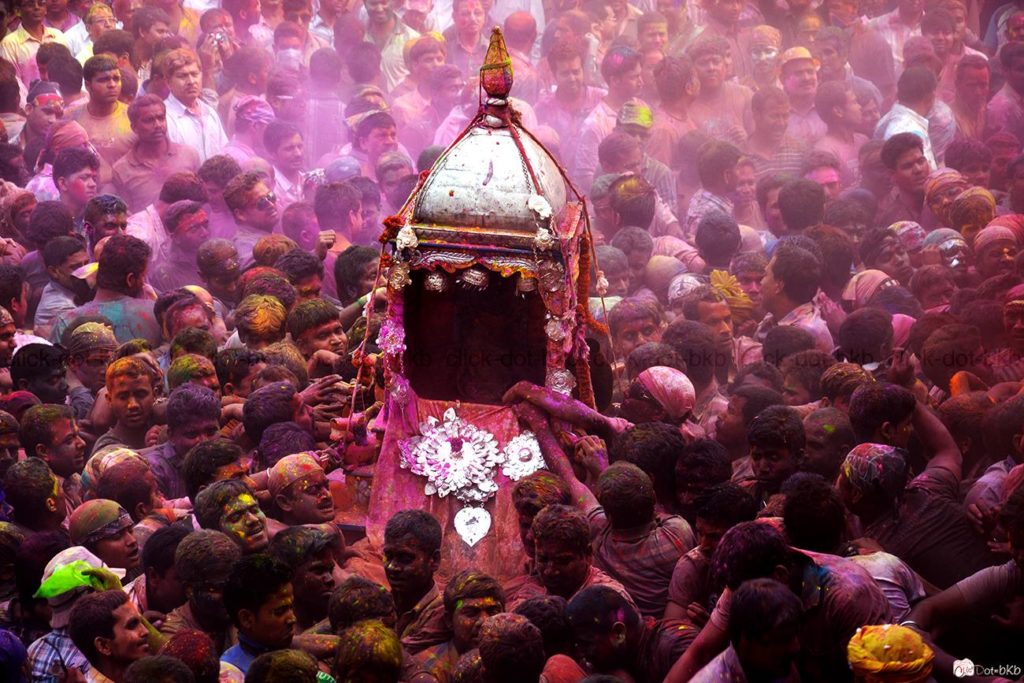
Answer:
(711, 549, 892, 681)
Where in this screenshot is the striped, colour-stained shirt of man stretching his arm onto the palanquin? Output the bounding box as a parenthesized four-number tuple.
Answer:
(591, 514, 695, 618)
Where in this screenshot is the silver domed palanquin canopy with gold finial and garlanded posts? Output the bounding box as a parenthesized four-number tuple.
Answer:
(381, 28, 591, 399)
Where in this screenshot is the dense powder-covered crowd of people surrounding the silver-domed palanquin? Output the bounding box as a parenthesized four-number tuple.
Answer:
(0, 0, 1024, 683)
